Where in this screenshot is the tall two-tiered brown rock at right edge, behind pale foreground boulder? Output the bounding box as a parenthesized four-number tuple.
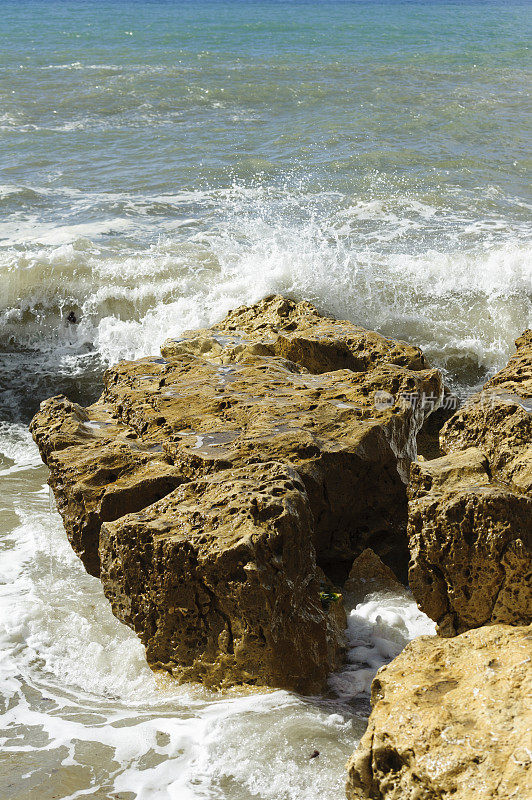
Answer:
(408, 331, 532, 636)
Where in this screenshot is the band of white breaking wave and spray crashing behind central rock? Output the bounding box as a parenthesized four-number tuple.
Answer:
(0, 185, 532, 416)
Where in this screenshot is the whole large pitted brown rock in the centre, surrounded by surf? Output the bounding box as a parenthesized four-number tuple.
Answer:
(32, 297, 443, 691)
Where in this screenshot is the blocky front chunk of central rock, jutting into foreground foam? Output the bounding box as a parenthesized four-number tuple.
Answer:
(100, 462, 345, 693)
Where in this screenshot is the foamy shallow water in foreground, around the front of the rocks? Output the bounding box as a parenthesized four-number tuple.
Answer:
(0, 425, 430, 800)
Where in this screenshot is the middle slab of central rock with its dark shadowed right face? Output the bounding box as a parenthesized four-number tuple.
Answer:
(103, 346, 441, 577)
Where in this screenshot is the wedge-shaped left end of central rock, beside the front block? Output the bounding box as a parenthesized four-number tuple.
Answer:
(31, 397, 181, 576)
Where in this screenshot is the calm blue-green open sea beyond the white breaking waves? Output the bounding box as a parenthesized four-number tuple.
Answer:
(0, 0, 530, 192)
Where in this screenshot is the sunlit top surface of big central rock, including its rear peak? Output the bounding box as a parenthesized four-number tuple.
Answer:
(96, 297, 442, 484)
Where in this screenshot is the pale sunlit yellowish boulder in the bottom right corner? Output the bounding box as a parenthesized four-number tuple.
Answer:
(346, 625, 532, 800)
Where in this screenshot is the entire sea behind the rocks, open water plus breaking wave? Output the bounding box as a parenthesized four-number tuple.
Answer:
(0, 0, 532, 416)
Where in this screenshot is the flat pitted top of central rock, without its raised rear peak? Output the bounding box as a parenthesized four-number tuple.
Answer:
(103, 354, 440, 468)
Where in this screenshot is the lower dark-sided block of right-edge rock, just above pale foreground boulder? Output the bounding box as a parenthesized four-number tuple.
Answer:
(408, 447, 532, 636)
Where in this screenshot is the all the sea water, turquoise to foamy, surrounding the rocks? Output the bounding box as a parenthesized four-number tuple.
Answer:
(0, 0, 532, 800)
